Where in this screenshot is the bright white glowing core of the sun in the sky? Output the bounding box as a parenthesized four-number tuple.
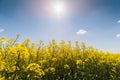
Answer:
(52, 2, 66, 16)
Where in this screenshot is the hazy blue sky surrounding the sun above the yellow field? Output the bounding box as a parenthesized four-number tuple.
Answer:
(0, 0, 120, 52)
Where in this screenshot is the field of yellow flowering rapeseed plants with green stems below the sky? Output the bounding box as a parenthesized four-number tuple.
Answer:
(0, 35, 120, 80)
